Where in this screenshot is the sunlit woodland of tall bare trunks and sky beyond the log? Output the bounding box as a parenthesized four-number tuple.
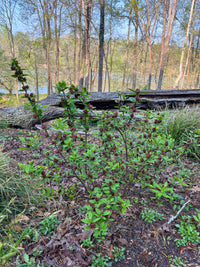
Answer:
(0, 0, 200, 95)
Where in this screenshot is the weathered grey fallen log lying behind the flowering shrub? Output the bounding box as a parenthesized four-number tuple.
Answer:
(0, 90, 200, 129)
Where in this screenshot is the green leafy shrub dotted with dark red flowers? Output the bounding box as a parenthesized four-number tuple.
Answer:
(11, 60, 186, 245)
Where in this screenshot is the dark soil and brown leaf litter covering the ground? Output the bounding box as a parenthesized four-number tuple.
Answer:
(0, 129, 200, 267)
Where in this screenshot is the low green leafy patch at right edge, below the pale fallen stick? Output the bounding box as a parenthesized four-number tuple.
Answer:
(175, 220, 200, 247)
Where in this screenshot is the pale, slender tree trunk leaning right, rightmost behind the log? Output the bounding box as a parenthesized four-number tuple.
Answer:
(173, 0, 196, 88)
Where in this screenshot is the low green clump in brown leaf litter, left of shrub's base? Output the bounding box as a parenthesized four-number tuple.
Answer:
(38, 216, 60, 235)
